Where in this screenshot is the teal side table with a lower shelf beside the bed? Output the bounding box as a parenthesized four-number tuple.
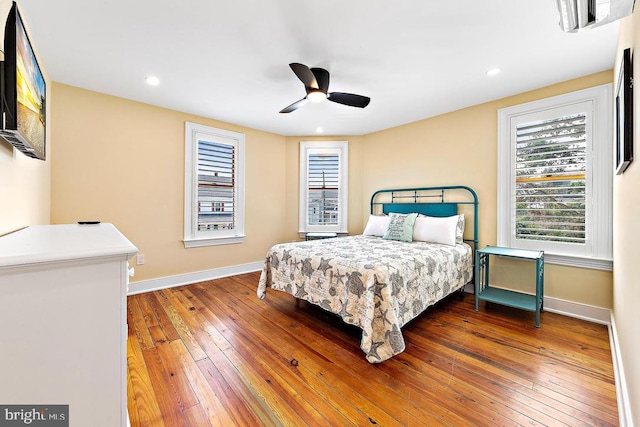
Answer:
(475, 246, 544, 328)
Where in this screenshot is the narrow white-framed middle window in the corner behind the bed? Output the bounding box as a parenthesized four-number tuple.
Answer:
(299, 141, 348, 233)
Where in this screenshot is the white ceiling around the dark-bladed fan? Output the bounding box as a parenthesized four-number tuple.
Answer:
(19, 0, 618, 136)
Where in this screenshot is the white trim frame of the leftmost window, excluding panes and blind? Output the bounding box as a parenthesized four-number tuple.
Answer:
(183, 122, 245, 248)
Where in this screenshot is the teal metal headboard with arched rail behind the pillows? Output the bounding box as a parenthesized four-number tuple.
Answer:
(370, 185, 478, 251)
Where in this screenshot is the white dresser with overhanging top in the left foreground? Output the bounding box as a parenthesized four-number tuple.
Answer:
(0, 224, 138, 427)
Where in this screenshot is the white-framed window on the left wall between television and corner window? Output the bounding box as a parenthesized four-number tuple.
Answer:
(184, 122, 244, 248)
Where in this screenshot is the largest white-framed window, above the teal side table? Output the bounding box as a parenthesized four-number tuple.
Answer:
(498, 85, 613, 270)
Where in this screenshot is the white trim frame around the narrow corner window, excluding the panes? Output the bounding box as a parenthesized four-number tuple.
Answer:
(298, 141, 349, 235)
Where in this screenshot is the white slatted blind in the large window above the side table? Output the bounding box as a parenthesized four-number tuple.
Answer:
(514, 113, 587, 244)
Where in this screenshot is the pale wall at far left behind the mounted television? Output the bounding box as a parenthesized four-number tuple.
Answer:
(0, 0, 53, 235)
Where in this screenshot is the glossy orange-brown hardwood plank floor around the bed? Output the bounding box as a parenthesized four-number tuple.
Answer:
(128, 273, 618, 427)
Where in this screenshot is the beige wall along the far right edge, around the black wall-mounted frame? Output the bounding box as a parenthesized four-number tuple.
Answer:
(613, 5, 640, 426)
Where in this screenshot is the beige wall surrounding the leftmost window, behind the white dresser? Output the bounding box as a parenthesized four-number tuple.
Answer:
(51, 83, 286, 281)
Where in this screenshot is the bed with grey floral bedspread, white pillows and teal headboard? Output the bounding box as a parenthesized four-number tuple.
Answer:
(257, 186, 478, 363)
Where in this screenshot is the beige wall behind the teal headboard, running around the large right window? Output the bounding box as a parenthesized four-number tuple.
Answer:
(361, 71, 613, 308)
